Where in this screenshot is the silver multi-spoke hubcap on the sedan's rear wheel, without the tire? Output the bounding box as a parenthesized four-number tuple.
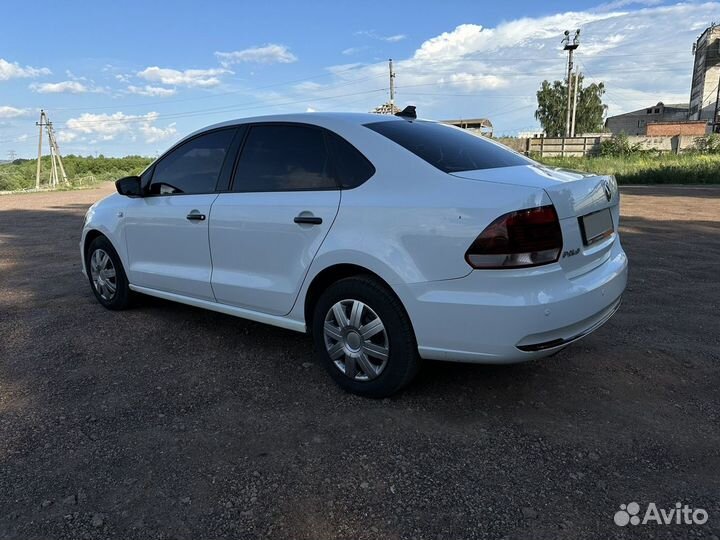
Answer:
(323, 299, 390, 381)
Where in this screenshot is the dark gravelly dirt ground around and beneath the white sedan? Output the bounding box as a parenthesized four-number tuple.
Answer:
(0, 185, 720, 540)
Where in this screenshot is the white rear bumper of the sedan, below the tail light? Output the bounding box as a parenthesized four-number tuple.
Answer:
(398, 239, 628, 364)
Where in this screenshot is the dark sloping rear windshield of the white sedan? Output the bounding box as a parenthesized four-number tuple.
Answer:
(365, 120, 530, 173)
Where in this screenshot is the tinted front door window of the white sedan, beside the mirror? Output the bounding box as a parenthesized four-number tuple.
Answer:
(149, 129, 235, 195)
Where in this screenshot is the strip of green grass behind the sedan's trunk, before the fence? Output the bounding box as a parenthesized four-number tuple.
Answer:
(536, 154, 720, 184)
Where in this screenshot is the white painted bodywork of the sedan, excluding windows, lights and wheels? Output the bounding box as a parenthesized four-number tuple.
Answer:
(80, 113, 627, 363)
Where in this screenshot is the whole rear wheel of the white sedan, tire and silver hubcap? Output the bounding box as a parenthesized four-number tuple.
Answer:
(313, 276, 420, 398)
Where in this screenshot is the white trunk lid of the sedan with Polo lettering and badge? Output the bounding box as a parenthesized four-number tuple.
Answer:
(452, 164, 620, 278)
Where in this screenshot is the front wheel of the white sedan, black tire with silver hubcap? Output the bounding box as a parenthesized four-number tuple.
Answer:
(85, 236, 131, 310)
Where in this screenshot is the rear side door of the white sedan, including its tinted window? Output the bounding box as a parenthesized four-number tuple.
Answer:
(210, 123, 340, 315)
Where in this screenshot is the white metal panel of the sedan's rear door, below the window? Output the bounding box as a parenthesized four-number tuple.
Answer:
(210, 190, 341, 315)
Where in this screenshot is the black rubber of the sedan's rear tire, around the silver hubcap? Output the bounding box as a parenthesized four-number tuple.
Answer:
(312, 276, 420, 398)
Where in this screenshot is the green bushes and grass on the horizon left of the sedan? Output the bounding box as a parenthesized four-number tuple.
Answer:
(0, 155, 152, 191)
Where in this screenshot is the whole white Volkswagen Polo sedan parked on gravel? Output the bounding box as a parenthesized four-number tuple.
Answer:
(80, 110, 628, 397)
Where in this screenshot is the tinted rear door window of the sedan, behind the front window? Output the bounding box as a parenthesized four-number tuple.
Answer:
(233, 124, 337, 192)
